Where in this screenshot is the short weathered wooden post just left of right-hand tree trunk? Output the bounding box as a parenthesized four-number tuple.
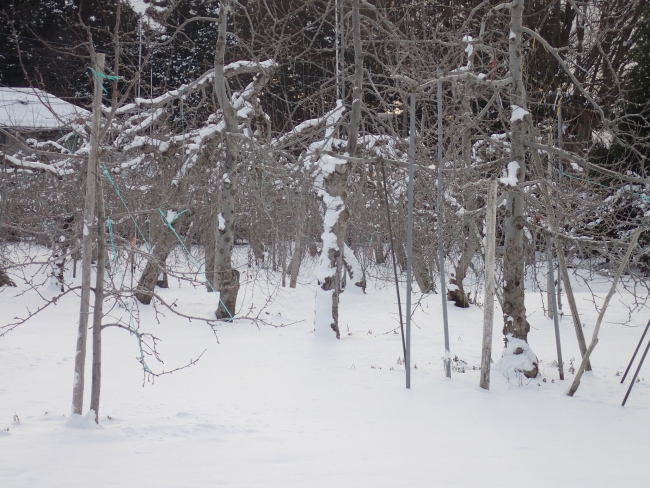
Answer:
(479, 178, 497, 390)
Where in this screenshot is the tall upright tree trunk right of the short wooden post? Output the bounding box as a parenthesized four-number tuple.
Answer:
(503, 0, 538, 378)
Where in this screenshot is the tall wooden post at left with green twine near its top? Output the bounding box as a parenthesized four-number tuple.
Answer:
(72, 50, 104, 415)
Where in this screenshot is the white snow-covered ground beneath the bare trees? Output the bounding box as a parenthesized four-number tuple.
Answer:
(0, 250, 650, 488)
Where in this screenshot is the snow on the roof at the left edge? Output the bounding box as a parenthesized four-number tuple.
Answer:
(0, 87, 90, 129)
